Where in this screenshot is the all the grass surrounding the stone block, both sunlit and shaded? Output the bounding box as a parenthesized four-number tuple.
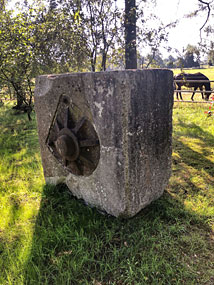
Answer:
(0, 98, 214, 285)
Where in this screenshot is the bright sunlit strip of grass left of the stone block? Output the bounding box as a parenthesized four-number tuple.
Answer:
(0, 102, 44, 284)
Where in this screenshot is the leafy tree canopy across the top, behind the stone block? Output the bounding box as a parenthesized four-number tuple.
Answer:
(0, 0, 214, 116)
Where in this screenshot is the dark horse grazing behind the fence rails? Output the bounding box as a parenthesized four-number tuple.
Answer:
(174, 72, 211, 101)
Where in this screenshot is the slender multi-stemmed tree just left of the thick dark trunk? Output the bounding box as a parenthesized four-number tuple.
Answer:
(82, 0, 121, 71)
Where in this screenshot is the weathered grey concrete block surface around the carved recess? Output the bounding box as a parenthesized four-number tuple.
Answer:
(35, 70, 173, 217)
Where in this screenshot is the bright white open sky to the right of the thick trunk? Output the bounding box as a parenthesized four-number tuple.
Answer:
(118, 0, 213, 57)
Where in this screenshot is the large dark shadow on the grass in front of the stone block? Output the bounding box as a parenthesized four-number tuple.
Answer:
(25, 181, 212, 284)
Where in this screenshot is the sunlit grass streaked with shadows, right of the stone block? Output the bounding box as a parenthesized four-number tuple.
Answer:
(171, 103, 214, 227)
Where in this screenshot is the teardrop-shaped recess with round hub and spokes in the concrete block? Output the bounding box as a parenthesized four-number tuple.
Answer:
(46, 95, 100, 176)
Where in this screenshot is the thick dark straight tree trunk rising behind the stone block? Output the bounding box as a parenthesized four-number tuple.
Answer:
(125, 0, 137, 69)
